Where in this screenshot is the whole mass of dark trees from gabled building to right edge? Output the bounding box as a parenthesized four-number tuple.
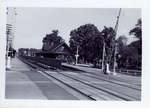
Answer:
(69, 19, 142, 68)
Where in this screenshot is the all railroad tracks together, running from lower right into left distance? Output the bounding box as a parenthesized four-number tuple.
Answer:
(18, 59, 141, 101)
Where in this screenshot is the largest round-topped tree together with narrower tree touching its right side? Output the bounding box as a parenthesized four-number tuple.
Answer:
(69, 24, 115, 69)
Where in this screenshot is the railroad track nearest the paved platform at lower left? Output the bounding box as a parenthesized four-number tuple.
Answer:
(43, 71, 127, 101)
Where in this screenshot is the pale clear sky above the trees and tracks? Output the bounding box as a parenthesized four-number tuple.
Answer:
(7, 7, 141, 49)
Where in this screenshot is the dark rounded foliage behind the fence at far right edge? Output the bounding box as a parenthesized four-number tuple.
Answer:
(117, 41, 142, 69)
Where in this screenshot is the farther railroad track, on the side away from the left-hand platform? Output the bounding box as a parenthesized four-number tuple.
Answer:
(57, 72, 140, 100)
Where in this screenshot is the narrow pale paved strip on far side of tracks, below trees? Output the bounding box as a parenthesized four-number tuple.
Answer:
(62, 63, 141, 85)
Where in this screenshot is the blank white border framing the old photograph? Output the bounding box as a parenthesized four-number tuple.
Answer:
(0, 0, 150, 108)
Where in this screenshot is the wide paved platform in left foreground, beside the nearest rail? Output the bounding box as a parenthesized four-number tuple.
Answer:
(5, 58, 77, 100)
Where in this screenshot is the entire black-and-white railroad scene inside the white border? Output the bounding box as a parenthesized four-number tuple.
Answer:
(5, 7, 142, 101)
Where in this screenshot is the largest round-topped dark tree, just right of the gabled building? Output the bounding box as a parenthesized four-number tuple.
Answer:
(69, 24, 102, 63)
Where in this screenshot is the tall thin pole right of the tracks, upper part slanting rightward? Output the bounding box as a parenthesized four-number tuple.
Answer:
(113, 8, 121, 75)
